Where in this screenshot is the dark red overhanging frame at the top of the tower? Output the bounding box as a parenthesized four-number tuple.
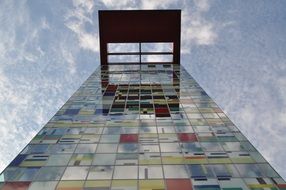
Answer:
(99, 10, 181, 66)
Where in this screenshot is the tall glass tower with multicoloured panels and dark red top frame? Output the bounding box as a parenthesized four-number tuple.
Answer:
(0, 10, 286, 190)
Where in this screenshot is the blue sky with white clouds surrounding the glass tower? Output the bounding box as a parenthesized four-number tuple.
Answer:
(0, 0, 286, 179)
